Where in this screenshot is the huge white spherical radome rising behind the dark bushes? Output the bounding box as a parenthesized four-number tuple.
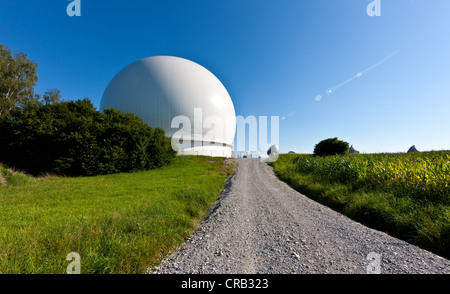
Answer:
(100, 56, 236, 157)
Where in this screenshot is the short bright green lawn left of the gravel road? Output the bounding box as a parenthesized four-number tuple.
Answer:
(0, 156, 234, 273)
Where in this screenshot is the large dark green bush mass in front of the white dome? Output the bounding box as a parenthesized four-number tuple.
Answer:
(0, 99, 175, 176)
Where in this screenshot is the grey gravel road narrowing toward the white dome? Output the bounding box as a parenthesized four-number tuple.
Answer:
(148, 159, 450, 274)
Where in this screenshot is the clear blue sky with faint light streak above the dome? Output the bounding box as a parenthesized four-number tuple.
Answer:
(0, 0, 450, 153)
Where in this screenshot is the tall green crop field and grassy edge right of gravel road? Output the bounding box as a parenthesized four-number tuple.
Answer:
(272, 153, 450, 258)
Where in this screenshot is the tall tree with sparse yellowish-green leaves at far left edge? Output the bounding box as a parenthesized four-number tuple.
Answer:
(0, 44, 38, 118)
